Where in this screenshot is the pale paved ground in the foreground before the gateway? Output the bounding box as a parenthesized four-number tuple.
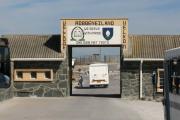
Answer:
(0, 97, 163, 120)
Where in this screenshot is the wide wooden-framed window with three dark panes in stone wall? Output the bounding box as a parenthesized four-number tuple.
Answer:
(14, 69, 53, 81)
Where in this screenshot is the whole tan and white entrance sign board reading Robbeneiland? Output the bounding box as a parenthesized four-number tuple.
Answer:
(61, 18, 128, 50)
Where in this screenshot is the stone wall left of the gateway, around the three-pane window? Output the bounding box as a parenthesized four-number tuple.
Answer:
(13, 61, 69, 97)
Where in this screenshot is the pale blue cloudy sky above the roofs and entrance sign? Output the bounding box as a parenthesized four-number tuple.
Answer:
(0, 0, 180, 35)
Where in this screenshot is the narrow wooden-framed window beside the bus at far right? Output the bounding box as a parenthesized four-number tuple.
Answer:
(157, 69, 164, 92)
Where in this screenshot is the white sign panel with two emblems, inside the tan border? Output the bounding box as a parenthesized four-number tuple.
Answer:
(67, 25, 122, 45)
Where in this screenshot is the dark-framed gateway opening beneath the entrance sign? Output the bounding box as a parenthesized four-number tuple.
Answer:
(68, 45, 122, 97)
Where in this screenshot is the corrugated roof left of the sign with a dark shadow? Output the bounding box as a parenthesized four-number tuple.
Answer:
(3, 35, 63, 59)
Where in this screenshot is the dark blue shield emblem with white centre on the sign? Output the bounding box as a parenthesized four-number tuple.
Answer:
(102, 28, 113, 40)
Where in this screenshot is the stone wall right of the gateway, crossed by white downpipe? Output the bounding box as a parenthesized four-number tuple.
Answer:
(121, 61, 163, 99)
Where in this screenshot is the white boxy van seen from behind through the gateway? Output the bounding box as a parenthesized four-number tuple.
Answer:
(89, 63, 109, 87)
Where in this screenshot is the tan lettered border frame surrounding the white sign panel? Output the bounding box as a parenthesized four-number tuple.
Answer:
(61, 18, 128, 52)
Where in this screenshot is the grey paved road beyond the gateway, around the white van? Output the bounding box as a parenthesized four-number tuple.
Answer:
(72, 71, 120, 95)
